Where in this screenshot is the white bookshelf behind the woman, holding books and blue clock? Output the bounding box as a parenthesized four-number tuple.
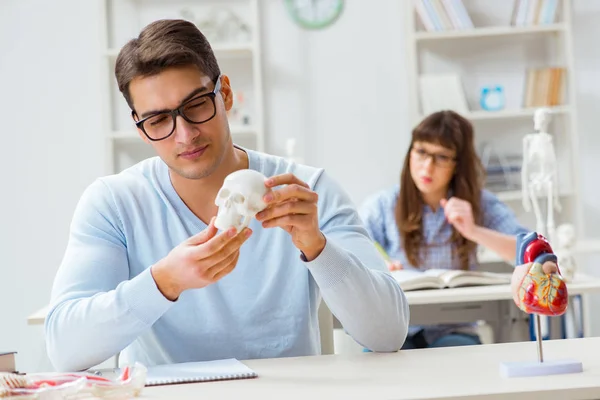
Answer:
(404, 0, 600, 255)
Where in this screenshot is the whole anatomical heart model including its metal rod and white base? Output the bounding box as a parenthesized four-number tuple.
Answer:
(500, 232, 583, 377)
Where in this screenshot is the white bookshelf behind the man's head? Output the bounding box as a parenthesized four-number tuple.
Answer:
(100, 0, 265, 174)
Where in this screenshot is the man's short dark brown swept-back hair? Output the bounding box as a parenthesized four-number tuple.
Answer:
(115, 19, 221, 110)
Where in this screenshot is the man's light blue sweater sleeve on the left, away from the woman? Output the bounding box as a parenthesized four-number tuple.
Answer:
(45, 180, 173, 371)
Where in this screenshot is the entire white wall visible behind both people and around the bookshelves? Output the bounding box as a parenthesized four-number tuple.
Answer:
(0, 0, 600, 371)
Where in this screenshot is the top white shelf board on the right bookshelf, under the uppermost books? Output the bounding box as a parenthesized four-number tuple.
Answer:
(415, 24, 565, 41)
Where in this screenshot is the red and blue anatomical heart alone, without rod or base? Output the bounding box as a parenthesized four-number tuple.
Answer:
(514, 232, 569, 316)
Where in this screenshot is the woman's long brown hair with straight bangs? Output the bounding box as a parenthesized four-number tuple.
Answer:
(396, 111, 485, 270)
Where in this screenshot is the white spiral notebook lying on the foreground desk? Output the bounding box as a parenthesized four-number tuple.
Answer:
(146, 358, 258, 386)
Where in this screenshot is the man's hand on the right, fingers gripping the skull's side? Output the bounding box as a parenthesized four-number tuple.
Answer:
(256, 174, 326, 261)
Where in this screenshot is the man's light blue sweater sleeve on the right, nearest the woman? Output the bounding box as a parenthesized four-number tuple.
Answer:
(307, 173, 410, 352)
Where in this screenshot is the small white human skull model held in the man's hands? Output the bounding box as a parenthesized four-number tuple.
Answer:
(215, 169, 270, 232)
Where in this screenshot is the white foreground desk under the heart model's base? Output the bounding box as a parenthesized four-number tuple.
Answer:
(140, 338, 600, 400)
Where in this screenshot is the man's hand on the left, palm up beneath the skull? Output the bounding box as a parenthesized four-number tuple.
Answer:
(151, 218, 252, 301)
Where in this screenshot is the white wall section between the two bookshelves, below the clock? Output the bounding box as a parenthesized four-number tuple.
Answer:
(263, 0, 410, 203)
